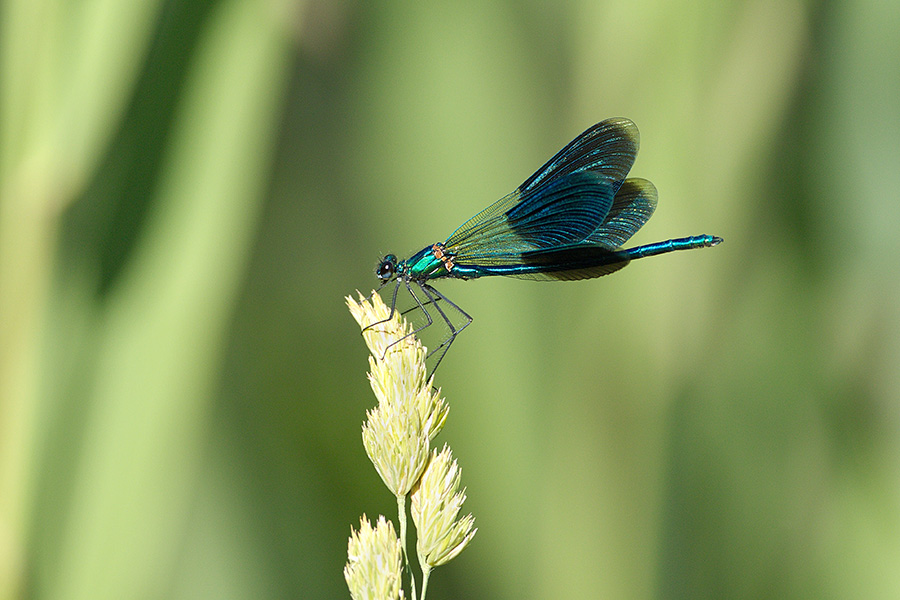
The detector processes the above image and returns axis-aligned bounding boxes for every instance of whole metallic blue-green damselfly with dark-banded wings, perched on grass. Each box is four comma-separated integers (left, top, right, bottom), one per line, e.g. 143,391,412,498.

370,118,722,372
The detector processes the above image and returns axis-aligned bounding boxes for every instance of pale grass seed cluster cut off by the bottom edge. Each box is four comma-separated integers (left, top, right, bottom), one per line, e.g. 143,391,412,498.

344,515,403,600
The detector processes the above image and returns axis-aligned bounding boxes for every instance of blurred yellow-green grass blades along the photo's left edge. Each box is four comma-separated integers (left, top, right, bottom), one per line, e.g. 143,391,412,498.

0,0,160,598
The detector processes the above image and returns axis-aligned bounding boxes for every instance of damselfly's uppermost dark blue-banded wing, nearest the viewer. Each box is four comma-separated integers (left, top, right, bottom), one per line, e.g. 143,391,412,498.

444,119,638,265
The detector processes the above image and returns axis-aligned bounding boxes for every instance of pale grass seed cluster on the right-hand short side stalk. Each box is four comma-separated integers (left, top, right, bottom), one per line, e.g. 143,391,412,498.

410,445,478,568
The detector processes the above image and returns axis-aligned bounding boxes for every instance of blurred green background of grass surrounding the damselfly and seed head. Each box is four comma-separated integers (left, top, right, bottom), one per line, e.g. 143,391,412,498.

0,0,900,599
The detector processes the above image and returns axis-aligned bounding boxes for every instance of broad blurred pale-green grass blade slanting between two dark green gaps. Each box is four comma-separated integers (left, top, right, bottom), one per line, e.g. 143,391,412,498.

48,0,289,599
